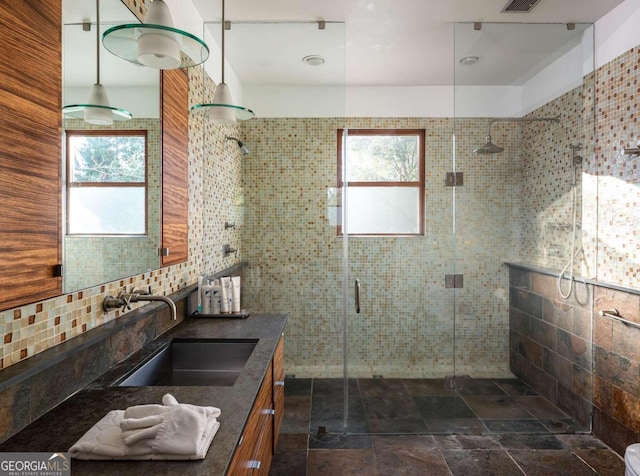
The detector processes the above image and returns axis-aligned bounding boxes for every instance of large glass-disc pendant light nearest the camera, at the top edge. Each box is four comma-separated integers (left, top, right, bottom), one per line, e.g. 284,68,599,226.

102,0,209,69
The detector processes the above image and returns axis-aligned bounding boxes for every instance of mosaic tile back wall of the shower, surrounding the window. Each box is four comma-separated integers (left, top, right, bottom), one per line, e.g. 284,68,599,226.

243,118,519,377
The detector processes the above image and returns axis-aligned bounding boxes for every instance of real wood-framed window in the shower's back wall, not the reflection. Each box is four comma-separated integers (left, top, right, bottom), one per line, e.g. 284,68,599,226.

338,129,424,236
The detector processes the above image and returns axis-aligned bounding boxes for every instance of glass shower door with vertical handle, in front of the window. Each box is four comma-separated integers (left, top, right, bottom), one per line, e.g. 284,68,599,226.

342,118,454,434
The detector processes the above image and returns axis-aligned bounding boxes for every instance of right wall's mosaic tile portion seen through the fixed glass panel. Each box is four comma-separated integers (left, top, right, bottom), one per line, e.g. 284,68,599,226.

521,79,595,277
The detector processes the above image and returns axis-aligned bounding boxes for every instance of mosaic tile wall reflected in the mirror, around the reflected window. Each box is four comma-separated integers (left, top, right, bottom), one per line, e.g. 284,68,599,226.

63,118,160,292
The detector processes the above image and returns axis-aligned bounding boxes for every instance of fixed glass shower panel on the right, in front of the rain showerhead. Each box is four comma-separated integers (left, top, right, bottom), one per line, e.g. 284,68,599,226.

454,23,593,430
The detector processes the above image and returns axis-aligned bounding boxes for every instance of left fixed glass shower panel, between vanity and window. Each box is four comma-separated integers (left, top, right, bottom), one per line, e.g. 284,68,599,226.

235,21,352,433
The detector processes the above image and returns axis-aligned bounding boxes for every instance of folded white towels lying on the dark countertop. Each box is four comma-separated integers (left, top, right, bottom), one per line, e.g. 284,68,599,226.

69,396,220,460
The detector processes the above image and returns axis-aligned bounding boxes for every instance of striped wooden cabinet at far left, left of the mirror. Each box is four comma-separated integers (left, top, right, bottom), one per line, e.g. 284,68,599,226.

0,0,62,310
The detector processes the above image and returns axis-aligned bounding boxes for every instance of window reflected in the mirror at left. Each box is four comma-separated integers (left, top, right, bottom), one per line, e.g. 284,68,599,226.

67,130,147,236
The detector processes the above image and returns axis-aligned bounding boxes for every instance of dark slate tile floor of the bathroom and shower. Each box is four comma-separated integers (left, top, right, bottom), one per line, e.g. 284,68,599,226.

270,378,624,476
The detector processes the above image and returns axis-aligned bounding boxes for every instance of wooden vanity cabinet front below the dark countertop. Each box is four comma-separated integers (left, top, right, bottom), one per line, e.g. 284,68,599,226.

227,337,284,476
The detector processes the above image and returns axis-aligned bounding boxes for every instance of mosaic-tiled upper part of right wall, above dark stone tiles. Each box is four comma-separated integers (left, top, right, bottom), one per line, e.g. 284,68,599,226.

522,48,640,290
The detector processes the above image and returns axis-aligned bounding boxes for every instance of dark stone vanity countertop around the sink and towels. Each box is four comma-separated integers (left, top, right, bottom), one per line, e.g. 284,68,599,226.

0,315,287,476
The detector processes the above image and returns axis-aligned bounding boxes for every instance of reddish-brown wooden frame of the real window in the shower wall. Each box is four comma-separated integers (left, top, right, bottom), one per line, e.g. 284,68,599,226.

336,128,426,238
